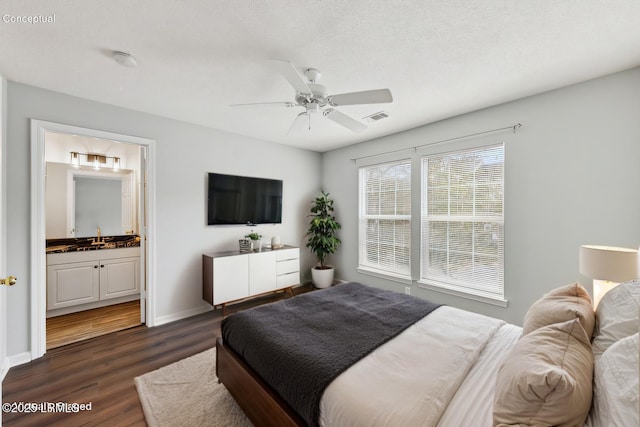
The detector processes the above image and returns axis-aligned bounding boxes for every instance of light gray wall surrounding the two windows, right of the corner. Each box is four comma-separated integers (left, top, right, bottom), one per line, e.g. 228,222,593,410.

322,68,640,324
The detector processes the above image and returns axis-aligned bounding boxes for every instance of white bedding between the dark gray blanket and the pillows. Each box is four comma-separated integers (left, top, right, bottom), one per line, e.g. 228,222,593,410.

320,306,520,427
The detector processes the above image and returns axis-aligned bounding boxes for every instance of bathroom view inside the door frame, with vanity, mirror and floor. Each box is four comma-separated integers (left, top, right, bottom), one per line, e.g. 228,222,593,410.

44,131,144,350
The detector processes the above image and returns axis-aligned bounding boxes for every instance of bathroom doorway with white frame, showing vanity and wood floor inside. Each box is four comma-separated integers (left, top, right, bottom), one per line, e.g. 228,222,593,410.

32,120,154,359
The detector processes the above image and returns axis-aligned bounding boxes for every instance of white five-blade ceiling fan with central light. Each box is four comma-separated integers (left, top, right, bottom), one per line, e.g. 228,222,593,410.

231,59,393,134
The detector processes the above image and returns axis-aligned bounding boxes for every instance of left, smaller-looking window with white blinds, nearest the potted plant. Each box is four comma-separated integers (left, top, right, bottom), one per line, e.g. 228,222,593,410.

359,159,411,279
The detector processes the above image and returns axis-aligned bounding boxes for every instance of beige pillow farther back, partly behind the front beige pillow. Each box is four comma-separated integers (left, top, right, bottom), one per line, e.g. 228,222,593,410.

522,283,595,337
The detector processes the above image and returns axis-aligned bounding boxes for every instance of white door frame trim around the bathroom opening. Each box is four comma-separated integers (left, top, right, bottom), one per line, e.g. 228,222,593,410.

30,119,156,360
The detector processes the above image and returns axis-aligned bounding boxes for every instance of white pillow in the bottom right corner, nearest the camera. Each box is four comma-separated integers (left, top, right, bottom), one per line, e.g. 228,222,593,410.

590,333,640,427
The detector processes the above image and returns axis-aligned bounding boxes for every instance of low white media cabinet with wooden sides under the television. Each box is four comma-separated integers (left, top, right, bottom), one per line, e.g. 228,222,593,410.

202,246,300,315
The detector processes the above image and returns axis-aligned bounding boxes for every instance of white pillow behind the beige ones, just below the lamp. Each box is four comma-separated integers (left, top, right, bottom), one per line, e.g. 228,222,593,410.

592,282,640,360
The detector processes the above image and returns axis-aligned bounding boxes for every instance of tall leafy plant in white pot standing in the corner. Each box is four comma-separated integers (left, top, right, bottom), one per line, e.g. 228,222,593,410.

307,191,340,288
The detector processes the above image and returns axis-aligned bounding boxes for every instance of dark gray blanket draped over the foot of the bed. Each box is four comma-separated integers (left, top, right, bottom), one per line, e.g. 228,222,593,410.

222,283,438,426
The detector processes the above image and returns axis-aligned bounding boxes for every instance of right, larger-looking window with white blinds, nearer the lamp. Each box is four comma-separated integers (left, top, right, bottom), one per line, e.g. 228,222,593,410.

420,144,504,300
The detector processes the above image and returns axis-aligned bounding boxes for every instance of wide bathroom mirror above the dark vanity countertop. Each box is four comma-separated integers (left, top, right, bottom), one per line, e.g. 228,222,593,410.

45,162,137,239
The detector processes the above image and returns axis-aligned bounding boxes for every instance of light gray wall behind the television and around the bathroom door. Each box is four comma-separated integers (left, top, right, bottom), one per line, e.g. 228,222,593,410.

6,82,321,355
